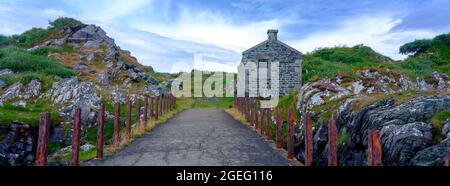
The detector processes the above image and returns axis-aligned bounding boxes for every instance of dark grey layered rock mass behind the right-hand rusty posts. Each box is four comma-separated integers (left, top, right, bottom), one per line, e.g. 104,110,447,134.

295,96,450,165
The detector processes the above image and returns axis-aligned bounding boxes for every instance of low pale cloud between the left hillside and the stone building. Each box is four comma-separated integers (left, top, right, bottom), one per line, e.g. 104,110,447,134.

102,25,241,72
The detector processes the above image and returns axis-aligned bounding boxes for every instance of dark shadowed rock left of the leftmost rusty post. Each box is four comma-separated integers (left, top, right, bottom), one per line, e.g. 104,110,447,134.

0,122,34,166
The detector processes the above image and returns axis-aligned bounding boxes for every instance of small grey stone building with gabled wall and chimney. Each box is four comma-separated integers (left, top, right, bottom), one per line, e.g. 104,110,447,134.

239,29,302,97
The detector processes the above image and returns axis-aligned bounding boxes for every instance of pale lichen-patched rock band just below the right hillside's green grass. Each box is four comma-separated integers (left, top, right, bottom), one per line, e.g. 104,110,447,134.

298,69,450,110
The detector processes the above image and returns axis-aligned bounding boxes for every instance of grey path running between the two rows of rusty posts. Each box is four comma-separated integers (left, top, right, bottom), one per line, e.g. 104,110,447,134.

95,109,291,166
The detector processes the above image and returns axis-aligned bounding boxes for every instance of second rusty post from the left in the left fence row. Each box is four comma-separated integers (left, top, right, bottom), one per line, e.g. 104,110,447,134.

69,108,81,166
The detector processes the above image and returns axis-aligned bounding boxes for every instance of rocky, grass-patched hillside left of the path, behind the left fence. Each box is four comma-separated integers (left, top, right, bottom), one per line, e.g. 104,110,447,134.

0,18,168,165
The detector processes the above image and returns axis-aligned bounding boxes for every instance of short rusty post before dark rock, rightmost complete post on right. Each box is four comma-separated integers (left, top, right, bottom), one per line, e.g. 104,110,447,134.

367,130,383,166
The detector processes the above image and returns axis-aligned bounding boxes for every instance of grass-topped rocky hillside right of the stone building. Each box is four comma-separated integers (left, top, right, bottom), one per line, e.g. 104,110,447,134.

290,34,450,165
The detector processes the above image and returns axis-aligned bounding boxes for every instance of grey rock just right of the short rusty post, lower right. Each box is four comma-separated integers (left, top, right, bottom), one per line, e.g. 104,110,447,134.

380,122,432,166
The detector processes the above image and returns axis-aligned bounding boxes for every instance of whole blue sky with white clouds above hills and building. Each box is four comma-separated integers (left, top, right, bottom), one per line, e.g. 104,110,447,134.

0,0,450,72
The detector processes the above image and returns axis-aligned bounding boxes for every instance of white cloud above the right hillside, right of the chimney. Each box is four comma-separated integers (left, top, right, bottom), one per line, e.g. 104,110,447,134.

287,15,438,59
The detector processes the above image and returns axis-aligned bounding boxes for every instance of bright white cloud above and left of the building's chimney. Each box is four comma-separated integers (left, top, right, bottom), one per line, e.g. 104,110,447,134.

130,7,289,53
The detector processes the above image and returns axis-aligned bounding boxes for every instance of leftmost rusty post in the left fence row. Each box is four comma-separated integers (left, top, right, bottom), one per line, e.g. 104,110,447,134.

36,112,50,166
